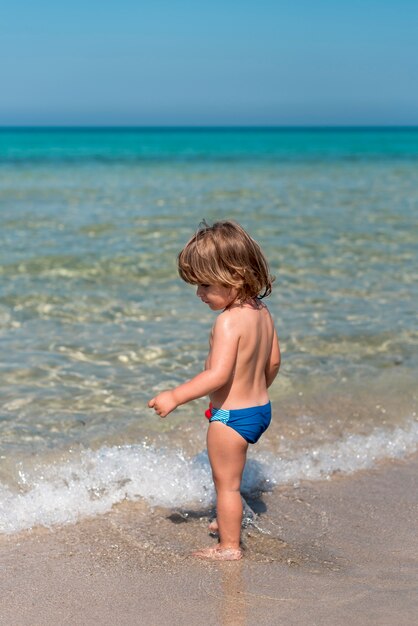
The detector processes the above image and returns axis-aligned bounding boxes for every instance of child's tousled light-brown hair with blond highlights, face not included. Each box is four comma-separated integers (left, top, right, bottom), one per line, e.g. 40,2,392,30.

178,221,274,302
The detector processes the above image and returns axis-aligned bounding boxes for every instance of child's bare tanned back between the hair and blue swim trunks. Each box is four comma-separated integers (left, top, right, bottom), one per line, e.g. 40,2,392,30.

206,300,280,410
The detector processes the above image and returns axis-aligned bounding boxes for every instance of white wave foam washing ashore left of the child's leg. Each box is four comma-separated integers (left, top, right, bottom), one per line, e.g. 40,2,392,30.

0,445,213,533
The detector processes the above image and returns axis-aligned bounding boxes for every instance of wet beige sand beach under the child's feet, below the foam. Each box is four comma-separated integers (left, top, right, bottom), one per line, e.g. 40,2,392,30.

0,456,418,626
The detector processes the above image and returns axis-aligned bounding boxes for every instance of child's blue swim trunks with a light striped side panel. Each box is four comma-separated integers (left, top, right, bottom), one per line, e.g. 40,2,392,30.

209,402,271,443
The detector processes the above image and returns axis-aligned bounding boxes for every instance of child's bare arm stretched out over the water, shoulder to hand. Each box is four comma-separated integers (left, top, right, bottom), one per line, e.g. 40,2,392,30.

148,314,239,417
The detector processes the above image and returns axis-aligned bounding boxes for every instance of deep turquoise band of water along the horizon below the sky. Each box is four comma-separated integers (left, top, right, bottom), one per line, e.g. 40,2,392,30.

0,128,418,163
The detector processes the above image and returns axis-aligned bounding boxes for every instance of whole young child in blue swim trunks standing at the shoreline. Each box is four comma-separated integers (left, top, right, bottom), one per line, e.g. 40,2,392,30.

148,221,280,561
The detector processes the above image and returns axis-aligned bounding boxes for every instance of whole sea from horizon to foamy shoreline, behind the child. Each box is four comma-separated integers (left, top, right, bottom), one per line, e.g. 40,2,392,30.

0,128,418,534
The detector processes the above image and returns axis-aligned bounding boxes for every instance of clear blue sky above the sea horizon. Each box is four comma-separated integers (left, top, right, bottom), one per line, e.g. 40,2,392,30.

0,0,418,126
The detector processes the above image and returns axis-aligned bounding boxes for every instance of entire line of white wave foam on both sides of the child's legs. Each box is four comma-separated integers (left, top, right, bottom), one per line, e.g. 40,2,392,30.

0,421,418,533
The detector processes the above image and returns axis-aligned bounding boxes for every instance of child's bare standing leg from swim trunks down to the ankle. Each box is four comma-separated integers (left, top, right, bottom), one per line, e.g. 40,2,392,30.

207,422,248,549
